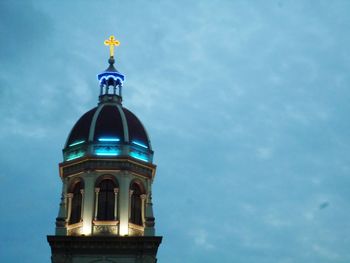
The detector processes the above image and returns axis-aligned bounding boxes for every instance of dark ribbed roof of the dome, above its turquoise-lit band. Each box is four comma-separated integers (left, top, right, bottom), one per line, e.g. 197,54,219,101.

65,103,151,150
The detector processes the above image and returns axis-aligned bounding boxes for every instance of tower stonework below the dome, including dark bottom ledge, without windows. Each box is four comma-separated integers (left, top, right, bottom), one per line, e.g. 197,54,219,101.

48,157,162,263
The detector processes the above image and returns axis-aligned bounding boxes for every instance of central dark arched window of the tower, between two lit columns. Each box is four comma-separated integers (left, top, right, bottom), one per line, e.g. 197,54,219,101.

97,179,116,220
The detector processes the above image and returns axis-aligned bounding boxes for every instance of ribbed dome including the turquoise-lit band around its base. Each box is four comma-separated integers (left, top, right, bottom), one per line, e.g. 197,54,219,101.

63,95,153,162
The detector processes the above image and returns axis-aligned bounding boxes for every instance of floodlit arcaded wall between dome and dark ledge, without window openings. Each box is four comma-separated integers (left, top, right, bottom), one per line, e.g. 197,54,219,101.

56,158,156,236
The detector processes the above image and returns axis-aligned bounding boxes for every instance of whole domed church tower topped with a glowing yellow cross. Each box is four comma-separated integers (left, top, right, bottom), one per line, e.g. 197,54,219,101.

47,36,162,263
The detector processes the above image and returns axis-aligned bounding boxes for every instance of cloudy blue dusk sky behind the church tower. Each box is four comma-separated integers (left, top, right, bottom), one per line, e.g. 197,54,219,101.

0,0,350,263
